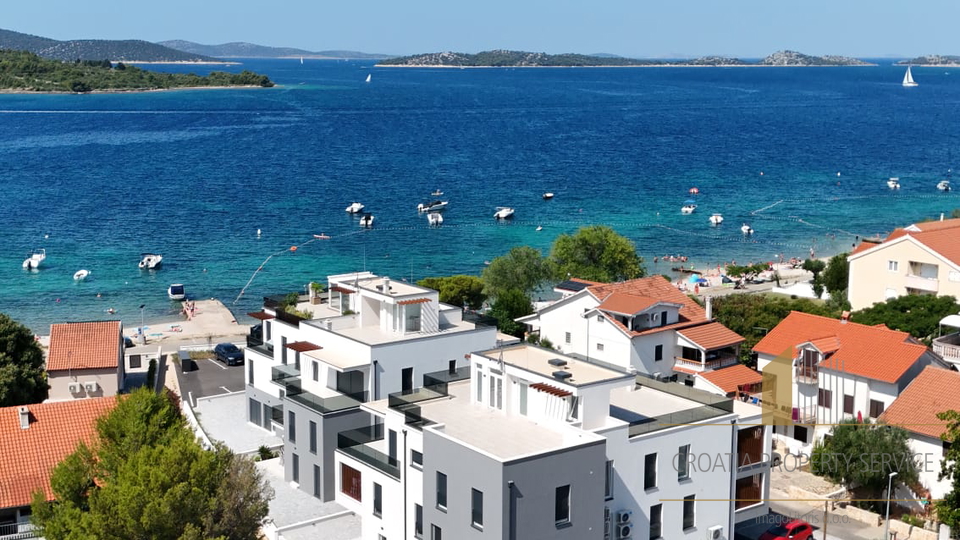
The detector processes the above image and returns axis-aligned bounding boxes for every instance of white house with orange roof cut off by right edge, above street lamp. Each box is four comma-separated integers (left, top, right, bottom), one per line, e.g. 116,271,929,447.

880,367,960,499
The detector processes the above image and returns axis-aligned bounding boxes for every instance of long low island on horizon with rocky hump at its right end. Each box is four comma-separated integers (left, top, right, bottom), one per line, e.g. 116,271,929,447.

377,50,875,67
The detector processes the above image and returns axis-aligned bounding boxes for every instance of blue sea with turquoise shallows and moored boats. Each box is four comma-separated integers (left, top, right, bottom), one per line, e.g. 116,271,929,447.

0,60,960,333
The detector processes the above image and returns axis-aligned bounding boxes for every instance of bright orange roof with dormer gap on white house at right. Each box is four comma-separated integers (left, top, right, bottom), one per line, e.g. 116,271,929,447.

753,311,927,383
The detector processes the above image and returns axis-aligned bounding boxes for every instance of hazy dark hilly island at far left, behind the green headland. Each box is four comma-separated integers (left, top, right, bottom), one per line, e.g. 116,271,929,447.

0,29,223,63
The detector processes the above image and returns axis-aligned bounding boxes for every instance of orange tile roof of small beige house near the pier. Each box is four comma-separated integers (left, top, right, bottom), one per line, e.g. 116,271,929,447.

47,321,122,371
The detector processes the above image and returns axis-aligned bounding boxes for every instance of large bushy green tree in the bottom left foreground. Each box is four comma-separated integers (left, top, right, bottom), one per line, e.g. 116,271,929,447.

33,389,273,540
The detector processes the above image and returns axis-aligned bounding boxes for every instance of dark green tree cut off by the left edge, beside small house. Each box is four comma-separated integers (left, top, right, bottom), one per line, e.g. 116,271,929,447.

0,313,48,407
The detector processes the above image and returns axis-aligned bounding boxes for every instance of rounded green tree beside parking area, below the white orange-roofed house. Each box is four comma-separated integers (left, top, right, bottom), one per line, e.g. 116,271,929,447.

811,419,919,506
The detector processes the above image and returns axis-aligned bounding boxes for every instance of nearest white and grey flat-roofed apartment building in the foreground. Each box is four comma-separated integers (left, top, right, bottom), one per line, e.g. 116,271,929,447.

336,344,770,540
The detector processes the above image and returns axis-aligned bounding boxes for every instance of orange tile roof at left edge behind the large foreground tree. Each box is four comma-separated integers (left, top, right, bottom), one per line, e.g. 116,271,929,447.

0,397,117,508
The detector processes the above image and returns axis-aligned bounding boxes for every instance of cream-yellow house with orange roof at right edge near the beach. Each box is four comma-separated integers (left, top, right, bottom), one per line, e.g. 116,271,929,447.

847,215,960,310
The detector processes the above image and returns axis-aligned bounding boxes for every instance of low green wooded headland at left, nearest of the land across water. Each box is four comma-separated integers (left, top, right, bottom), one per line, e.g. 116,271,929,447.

0,50,273,93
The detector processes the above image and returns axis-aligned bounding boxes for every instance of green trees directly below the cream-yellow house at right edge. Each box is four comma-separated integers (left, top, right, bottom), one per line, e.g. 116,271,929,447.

850,294,960,345
